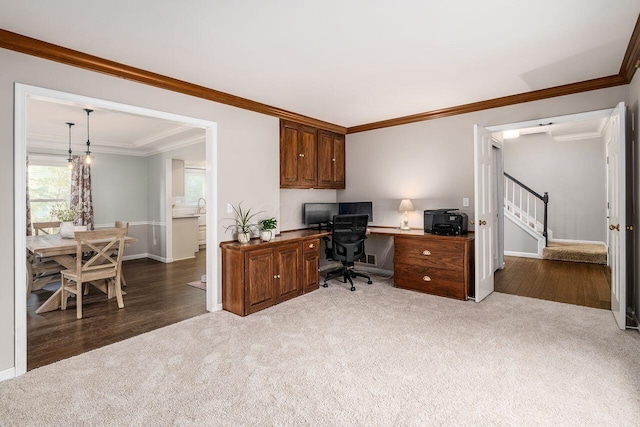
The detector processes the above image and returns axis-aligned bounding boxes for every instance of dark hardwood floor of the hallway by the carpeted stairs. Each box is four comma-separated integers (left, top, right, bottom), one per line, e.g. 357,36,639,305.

495,256,611,310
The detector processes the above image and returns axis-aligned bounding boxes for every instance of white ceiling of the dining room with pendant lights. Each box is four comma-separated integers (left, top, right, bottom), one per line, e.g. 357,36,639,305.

27,98,205,160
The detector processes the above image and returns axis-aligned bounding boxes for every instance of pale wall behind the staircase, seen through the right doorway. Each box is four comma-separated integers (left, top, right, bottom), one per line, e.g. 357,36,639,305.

503,133,607,242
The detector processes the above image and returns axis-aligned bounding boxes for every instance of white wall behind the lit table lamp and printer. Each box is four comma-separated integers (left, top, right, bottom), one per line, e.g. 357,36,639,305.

348,86,628,272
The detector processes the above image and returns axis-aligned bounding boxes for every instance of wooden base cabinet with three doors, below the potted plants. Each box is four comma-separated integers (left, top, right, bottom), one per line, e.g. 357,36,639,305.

221,234,320,316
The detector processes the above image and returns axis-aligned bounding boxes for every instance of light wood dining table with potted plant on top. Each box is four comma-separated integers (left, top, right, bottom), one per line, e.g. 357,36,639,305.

27,234,138,314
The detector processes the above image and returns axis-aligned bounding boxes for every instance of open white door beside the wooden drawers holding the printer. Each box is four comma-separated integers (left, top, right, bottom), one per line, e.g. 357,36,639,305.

473,125,496,302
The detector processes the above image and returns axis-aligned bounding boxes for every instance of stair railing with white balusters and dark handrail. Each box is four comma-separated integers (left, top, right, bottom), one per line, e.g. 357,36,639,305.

504,173,551,258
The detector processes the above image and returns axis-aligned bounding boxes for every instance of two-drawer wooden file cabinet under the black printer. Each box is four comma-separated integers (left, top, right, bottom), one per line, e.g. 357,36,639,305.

393,234,474,300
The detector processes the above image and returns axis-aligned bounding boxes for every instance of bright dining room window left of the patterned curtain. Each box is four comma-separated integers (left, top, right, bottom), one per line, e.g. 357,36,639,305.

29,156,71,222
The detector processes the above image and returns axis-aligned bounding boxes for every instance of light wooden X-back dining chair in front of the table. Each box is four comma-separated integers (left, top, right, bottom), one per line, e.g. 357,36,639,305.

60,228,127,319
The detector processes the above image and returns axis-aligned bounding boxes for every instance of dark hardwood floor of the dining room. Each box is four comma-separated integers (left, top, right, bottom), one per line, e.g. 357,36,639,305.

27,250,206,370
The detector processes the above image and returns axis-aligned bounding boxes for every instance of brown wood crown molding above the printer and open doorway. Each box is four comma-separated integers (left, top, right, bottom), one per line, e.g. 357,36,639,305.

347,75,627,134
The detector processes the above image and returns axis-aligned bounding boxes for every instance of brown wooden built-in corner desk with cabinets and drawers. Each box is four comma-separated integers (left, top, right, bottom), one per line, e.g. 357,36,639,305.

220,227,473,316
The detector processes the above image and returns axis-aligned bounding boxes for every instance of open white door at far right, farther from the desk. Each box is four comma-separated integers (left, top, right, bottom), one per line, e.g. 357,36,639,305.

607,102,627,329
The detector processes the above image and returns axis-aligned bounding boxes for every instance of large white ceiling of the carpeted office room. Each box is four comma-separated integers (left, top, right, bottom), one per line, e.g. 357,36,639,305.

0,0,640,127
